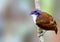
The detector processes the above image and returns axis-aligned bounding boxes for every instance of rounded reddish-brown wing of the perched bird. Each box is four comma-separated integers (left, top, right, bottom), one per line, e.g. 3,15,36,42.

36,12,56,29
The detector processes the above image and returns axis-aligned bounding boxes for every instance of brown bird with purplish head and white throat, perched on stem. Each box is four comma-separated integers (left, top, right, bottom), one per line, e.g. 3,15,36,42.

30,9,58,34
